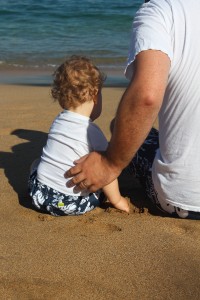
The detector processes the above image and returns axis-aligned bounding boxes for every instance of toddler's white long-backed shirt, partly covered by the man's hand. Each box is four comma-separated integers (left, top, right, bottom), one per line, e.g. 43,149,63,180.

37,110,108,196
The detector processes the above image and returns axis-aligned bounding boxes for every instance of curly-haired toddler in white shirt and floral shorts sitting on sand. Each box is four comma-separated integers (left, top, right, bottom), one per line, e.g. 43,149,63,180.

28,56,129,216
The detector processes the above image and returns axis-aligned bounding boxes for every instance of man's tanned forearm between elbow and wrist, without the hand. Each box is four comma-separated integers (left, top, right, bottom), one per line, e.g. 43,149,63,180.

106,84,159,170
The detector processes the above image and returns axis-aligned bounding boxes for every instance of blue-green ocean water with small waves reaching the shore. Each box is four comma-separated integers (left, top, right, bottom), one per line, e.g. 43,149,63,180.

0,0,144,84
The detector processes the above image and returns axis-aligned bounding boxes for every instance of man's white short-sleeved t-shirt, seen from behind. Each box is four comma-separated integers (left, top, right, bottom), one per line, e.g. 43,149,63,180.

125,0,200,211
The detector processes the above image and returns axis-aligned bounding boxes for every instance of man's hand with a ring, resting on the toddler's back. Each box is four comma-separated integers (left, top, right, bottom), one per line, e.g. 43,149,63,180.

65,152,121,192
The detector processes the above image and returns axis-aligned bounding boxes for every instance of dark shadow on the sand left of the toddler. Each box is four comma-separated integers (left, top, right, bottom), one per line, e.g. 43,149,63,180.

0,129,47,209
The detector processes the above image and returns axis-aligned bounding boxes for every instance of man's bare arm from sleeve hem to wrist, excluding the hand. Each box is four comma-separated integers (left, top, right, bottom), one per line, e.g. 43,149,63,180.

107,50,170,170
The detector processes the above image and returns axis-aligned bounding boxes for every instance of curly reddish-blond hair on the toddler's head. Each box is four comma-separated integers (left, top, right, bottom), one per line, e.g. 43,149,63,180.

51,55,106,109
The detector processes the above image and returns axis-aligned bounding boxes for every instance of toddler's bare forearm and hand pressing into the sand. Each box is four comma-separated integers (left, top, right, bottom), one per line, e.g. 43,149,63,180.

103,179,130,213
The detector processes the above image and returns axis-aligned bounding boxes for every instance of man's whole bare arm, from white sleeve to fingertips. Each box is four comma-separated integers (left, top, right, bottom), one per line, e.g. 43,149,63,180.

66,50,170,191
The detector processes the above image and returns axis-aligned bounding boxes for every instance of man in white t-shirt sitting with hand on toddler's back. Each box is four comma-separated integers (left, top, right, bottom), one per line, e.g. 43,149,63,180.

66,0,200,219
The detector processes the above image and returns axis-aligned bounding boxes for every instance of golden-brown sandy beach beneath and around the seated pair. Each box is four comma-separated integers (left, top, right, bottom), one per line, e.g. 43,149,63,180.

0,85,200,300
